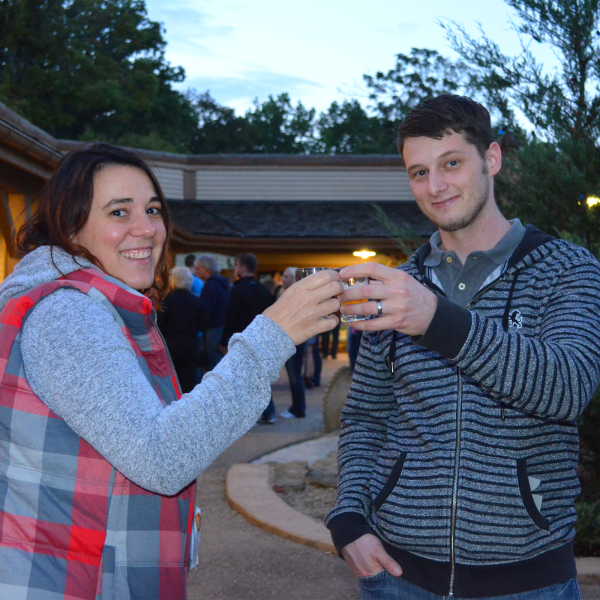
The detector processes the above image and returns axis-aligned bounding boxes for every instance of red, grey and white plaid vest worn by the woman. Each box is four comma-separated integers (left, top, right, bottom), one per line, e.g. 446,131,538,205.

0,268,195,600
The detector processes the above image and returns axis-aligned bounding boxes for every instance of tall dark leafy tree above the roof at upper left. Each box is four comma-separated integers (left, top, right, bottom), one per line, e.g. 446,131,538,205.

0,0,196,152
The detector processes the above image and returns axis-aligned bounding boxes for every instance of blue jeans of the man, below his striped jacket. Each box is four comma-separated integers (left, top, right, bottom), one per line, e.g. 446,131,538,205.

358,571,581,600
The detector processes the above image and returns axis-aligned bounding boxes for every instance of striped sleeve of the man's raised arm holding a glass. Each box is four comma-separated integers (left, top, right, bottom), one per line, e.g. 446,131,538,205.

416,258,600,421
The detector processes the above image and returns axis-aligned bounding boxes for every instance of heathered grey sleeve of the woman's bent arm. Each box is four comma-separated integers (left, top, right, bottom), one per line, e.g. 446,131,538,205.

21,290,294,495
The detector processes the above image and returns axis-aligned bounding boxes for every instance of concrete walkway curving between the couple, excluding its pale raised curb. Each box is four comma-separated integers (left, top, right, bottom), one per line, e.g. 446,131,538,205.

189,355,358,600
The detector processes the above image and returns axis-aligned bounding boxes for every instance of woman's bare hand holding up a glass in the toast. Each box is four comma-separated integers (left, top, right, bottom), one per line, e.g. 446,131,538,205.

263,270,344,346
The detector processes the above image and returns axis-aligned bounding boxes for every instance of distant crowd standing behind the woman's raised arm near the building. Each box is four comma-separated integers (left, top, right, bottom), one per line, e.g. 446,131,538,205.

158,253,362,425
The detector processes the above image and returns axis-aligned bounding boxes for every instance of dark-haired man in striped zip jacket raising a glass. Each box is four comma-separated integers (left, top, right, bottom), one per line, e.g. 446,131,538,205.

327,95,600,600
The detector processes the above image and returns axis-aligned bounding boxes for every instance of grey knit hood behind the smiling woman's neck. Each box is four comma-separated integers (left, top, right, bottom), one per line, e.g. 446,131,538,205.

0,246,95,310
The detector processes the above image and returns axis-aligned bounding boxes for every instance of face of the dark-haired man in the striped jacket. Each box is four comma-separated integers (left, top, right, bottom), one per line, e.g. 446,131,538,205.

403,132,501,231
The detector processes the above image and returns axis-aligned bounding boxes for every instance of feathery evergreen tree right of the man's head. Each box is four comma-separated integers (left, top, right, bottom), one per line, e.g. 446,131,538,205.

443,0,600,255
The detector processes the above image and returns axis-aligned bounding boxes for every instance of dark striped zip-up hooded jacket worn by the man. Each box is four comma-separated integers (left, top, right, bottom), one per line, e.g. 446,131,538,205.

326,226,600,598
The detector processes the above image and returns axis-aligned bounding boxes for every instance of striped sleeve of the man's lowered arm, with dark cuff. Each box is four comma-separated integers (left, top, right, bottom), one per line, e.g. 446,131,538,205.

325,331,397,553
